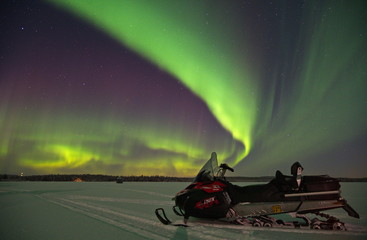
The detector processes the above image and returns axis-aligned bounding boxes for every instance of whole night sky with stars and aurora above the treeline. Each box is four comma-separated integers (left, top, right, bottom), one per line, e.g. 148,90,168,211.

0,0,367,177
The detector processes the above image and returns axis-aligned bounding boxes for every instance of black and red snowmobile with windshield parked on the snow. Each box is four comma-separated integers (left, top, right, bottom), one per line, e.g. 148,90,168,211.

155,152,359,230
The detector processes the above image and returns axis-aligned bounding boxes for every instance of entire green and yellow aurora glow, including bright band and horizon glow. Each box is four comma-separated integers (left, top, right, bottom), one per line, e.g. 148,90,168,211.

0,0,367,176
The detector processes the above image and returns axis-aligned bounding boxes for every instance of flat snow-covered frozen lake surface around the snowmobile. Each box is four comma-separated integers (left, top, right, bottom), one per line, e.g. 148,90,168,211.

0,182,367,240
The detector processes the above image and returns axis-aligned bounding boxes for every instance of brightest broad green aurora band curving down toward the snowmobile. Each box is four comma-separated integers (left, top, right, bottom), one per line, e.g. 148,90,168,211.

47,0,259,163
